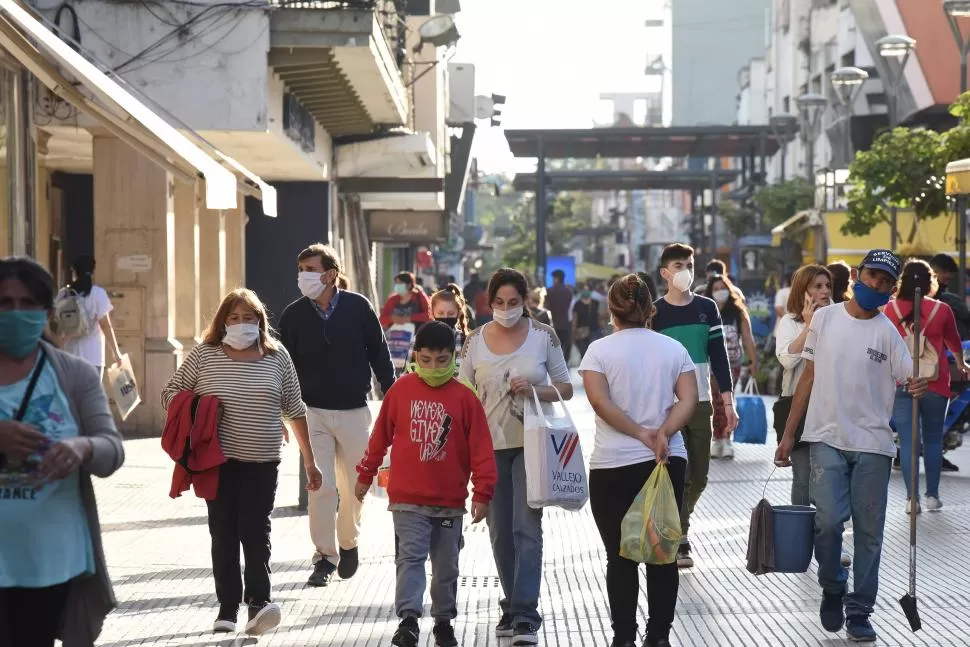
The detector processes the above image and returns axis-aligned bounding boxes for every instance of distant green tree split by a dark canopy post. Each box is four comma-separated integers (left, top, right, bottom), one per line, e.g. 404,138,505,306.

502,193,591,277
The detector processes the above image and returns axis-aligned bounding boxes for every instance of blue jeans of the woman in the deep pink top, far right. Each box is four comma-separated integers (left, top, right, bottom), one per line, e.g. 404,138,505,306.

893,389,950,497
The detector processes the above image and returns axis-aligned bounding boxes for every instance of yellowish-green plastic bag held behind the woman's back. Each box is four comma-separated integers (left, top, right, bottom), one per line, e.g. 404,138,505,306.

620,463,681,565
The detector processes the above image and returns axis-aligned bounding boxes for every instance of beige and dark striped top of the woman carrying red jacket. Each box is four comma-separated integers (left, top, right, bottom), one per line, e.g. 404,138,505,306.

162,344,306,463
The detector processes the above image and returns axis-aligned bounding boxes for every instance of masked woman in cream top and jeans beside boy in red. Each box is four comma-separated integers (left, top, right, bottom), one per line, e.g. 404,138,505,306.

459,268,573,645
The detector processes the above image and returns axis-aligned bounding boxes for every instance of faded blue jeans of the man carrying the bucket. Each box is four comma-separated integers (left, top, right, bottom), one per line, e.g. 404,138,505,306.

810,443,893,616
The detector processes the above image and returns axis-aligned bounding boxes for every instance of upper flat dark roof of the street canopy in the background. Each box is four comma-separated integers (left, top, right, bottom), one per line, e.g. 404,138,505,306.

505,125,792,159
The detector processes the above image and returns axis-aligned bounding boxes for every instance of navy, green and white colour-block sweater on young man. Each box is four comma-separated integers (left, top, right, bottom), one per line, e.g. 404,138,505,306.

652,295,733,402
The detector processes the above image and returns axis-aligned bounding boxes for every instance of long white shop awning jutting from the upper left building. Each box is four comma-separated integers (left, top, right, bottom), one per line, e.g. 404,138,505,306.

0,0,276,217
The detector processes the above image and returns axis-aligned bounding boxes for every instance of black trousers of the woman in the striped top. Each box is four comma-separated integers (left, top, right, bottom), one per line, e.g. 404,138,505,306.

206,460,279,609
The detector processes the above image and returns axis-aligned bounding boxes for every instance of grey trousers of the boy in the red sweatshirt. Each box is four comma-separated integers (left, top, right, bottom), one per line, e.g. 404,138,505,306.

393,511,462,621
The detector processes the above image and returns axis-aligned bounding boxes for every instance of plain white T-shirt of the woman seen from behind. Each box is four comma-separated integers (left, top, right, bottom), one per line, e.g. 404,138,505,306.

579,328,694,469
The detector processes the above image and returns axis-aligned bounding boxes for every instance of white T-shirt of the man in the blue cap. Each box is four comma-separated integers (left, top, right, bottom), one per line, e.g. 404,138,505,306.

802,303,913,457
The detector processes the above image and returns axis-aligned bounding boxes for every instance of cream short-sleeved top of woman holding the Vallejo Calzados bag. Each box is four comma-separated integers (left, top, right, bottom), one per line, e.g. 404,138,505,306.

458,319,569,450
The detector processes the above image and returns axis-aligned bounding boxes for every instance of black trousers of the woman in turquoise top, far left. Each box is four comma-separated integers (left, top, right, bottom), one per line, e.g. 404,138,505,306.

0,582,71,647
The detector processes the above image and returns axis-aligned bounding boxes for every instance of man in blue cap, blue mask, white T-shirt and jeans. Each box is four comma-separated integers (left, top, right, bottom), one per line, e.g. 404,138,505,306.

775,249,927,642
